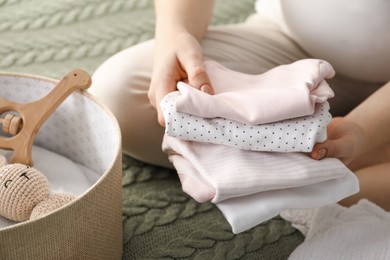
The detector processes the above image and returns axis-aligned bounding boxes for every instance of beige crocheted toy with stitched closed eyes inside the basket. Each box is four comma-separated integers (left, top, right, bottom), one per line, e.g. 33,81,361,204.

0,155,76,221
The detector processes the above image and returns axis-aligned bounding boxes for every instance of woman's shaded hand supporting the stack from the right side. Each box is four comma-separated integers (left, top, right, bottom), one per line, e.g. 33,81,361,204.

310,117,365,165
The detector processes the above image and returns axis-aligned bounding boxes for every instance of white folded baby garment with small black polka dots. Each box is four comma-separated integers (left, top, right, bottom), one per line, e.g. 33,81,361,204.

160,91,332,152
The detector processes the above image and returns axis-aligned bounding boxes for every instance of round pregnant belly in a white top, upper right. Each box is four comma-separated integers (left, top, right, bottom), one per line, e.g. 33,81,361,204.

281,0,390,82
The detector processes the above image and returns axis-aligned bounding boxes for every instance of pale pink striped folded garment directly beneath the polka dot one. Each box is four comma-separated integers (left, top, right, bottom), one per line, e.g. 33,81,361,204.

163,135,350,203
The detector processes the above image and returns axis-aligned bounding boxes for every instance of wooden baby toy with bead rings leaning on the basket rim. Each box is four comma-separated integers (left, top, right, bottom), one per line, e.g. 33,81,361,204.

0,69,91,165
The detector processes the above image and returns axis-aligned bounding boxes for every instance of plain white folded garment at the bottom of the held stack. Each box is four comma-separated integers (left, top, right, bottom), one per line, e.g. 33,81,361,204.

216,172,359,234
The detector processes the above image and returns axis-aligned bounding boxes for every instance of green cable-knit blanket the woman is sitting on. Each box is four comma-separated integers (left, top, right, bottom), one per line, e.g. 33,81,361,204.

0,0,303,260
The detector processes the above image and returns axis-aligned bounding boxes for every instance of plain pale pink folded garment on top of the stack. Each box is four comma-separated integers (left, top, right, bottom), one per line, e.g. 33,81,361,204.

176,59,335,124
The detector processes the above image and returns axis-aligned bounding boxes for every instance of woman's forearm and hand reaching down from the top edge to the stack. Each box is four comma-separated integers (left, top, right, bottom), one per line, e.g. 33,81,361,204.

148,0,214,126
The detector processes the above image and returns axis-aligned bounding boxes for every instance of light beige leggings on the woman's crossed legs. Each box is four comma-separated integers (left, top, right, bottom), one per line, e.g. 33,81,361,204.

90,14,380,168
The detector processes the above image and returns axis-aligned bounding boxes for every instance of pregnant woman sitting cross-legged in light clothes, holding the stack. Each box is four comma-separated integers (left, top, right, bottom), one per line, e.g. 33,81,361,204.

91,0,390,210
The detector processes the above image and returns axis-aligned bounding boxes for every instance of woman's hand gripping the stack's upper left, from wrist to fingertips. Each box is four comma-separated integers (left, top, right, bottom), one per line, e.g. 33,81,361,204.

148,32,213,126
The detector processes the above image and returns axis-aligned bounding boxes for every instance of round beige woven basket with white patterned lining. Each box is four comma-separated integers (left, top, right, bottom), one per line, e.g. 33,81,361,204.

0,73,122,260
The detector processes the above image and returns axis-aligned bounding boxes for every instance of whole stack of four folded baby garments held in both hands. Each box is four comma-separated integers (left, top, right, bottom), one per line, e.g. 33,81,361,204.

160,59,358,233
